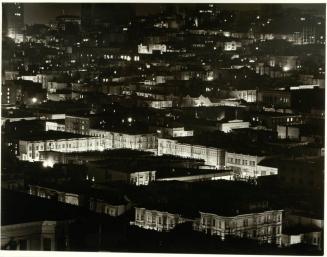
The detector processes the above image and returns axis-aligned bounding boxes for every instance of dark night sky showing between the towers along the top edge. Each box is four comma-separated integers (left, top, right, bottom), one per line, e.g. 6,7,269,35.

24,3,325,24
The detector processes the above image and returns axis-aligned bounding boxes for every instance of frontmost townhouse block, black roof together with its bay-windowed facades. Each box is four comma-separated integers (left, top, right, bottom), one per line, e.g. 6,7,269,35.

132,180,283,245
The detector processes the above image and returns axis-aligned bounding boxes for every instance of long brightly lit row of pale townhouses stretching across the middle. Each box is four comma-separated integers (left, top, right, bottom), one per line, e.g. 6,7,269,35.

19,129,278,177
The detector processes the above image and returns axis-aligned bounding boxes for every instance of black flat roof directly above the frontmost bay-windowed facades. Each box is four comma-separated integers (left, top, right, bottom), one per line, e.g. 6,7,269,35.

137,180,278,217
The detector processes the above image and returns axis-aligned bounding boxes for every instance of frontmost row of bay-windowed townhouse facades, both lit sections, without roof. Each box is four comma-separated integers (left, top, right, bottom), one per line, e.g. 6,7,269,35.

131,207,283,245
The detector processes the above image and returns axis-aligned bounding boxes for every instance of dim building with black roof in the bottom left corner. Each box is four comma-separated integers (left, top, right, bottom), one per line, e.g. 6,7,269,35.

1,189,81,251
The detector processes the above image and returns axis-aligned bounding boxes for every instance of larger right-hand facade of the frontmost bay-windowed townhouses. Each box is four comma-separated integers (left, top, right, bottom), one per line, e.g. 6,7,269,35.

198,210,282,245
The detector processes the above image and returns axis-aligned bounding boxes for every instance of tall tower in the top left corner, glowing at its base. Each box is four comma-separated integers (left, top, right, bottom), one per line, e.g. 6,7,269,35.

2,3,24,43
